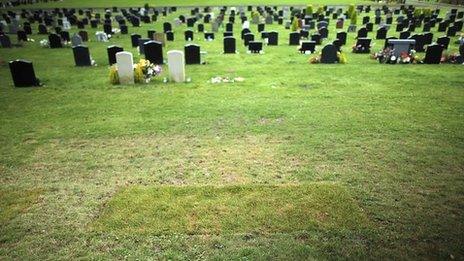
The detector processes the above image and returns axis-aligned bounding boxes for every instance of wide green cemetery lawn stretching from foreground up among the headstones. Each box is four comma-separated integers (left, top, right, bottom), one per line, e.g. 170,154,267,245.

0,4,464,260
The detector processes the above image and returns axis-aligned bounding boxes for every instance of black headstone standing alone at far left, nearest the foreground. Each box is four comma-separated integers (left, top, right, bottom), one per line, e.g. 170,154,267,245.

9,60,40,87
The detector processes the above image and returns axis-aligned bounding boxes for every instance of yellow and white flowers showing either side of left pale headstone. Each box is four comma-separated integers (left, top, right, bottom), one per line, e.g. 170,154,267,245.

109,59,163,84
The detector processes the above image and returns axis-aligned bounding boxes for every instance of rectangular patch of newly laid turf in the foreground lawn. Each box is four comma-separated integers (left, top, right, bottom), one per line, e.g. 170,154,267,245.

94,183,366,235
